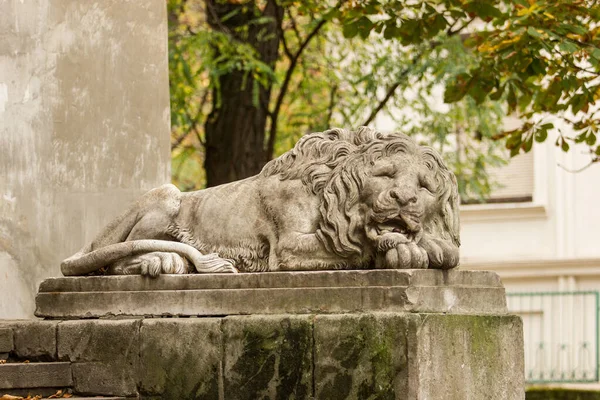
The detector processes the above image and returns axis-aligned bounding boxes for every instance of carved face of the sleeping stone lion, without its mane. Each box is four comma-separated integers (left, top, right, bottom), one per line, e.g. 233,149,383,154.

360,154,438,251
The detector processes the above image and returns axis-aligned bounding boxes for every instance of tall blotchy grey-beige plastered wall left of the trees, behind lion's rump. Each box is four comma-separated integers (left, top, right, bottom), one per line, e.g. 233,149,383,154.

0,0,170,318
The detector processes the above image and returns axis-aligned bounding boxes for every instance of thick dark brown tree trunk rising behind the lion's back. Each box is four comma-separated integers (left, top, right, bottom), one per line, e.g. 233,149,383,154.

204,0,283,186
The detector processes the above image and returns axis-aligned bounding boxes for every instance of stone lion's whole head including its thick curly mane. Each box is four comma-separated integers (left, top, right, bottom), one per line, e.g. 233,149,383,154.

262,127,460,268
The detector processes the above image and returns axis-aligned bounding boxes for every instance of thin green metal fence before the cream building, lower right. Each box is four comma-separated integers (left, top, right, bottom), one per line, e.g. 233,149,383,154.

506,291,600,383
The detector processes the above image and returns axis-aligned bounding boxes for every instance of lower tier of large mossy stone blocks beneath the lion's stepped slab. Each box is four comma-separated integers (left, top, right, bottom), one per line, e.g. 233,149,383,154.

2,312,524,400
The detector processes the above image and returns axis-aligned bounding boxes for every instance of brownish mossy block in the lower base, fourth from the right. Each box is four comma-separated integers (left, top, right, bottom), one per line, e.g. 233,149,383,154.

139,318,223,400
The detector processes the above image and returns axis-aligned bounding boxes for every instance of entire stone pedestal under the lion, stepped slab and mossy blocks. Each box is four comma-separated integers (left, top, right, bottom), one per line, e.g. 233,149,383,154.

27,270,524,400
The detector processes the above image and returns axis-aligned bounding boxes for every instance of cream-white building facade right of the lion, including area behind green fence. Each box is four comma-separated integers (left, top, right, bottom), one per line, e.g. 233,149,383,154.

461,130,600,384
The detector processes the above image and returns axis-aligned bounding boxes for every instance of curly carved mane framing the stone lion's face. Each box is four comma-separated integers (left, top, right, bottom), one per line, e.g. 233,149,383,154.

261,127,460,257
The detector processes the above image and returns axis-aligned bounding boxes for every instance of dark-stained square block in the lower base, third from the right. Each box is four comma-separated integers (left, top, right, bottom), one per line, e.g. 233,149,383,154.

223,316,313,400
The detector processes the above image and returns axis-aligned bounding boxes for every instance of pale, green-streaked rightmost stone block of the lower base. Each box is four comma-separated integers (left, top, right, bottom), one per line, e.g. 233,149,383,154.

407,314,525,400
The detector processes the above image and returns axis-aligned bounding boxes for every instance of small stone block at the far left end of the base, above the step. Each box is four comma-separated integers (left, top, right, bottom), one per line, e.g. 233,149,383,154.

2,320,58,361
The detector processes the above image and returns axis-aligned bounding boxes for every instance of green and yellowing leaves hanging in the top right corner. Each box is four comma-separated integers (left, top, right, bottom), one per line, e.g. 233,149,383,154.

339,0,600,162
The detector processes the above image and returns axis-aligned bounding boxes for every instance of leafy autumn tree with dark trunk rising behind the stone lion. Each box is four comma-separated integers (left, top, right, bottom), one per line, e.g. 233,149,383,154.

168,0,600,197
